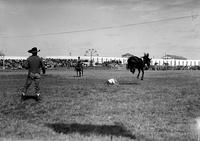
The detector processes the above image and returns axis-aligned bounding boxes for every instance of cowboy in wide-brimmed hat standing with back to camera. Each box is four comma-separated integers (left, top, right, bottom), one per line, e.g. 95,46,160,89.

22,47,46,101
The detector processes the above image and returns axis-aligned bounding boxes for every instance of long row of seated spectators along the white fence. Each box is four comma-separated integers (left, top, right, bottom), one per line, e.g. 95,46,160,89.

0,58,200,70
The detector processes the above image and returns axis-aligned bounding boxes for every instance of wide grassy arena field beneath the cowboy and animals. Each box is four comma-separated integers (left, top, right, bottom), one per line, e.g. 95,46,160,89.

0,70,200,141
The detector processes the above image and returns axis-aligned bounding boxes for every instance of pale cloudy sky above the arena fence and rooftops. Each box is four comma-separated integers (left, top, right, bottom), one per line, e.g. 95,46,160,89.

0,0,200,59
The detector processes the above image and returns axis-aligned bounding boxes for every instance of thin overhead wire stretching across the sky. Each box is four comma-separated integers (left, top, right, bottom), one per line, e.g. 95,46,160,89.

0,15,199,38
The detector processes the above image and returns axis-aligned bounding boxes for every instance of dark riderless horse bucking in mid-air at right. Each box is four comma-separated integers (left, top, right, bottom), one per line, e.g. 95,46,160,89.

127,53,151,80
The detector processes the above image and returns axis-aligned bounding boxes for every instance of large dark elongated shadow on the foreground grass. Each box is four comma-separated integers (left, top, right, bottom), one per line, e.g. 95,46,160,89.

46,123,136,139
